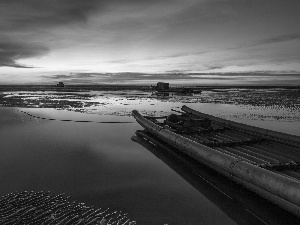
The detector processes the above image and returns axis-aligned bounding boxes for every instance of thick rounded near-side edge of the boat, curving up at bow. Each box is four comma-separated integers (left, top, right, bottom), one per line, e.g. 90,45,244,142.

132,110,300,217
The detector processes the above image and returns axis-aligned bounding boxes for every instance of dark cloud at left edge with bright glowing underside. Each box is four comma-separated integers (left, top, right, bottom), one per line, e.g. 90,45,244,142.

0,41,48,68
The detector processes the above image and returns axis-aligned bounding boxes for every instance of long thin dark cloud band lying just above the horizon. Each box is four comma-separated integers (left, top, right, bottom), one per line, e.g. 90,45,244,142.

43,71,300,85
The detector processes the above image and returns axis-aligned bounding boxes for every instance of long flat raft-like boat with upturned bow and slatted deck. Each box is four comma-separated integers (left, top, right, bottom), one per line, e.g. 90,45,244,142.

132,106,300,217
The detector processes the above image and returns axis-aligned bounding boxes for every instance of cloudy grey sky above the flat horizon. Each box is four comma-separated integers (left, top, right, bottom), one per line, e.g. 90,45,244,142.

0,0,300,85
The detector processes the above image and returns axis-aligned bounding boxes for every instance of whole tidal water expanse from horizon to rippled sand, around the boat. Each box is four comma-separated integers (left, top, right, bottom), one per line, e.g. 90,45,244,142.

0,85,300,225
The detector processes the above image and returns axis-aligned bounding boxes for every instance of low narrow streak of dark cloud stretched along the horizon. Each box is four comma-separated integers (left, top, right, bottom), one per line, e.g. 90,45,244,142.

40,71,300,85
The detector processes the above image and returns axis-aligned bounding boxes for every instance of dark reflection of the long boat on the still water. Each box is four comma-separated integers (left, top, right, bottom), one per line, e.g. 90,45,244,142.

132,131,299,225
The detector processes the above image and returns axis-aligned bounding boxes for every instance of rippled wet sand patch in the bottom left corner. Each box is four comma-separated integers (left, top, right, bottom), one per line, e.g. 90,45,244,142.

0,191,136,225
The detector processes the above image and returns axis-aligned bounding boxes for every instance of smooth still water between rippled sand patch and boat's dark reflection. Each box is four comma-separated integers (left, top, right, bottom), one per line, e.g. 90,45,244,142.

0,108,235,225
